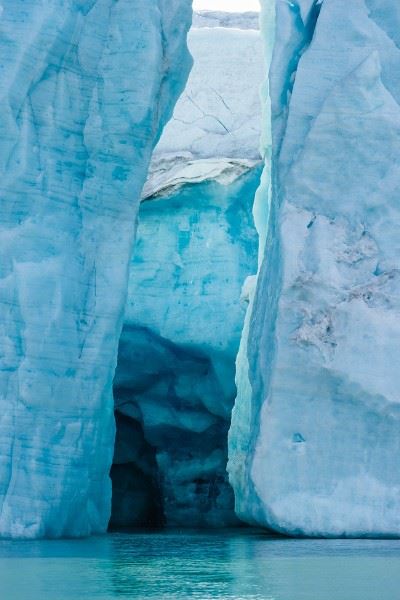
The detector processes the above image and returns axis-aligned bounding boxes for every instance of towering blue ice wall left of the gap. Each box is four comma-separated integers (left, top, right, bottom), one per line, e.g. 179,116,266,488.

0,0,191,538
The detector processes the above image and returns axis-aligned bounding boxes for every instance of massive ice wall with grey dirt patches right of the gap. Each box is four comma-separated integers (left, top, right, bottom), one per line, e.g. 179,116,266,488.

230,0,400,536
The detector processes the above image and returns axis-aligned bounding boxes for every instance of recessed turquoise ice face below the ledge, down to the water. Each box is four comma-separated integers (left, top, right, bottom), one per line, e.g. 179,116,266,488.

112,167,261,527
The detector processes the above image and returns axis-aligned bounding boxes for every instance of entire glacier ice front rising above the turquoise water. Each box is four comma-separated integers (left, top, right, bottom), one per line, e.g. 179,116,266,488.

0,0,400,543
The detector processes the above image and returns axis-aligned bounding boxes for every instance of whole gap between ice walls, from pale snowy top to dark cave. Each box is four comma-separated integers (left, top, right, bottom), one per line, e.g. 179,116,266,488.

110,4,265,529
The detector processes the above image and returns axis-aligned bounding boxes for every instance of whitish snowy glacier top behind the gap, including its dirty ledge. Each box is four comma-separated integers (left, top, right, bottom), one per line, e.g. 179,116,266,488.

143,12,265,198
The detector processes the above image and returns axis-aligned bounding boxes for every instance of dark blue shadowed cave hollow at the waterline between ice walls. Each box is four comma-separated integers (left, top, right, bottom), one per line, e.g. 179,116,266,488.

110,327,238,530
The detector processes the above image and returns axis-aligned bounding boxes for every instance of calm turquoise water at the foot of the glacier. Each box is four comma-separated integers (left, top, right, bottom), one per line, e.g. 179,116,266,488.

0,530,400,600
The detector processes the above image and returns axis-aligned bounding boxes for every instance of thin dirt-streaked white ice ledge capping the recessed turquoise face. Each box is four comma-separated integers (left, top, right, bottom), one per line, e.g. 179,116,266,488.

142,153,261,201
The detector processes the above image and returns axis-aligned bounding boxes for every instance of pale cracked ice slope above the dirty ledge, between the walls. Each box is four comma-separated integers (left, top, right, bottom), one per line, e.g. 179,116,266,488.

154,27,263,160
